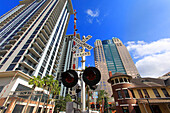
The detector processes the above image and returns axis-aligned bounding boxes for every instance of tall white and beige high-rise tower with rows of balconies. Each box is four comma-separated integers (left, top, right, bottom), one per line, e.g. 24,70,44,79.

0,0,73,112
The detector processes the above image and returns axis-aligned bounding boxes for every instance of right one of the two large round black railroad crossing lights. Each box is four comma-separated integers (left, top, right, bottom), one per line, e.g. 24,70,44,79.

83,67,101,87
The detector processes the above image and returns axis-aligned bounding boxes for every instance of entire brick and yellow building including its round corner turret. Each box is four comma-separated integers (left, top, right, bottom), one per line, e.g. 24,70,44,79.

108,73,170,113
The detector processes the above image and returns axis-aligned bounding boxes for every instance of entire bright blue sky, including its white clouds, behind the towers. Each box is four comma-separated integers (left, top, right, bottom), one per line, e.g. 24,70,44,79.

0,0,170,77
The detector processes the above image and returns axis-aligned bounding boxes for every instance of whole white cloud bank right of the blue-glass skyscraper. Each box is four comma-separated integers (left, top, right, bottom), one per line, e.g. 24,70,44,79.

127,38,170,77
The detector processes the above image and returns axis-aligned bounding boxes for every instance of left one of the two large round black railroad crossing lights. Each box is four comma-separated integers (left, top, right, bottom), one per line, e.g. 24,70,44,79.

61,70,78,88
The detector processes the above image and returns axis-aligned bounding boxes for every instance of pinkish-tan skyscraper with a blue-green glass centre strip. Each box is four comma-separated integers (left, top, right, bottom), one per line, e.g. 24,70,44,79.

94,37,140,90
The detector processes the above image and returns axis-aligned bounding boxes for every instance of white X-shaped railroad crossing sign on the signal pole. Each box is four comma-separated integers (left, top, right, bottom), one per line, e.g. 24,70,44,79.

72,35,93,51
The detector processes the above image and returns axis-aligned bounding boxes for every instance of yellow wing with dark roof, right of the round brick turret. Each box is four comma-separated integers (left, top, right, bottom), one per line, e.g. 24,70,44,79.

129,78,170,113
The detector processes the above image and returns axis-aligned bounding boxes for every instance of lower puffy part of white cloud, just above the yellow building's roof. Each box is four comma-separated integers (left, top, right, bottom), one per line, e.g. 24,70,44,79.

136,52,170,77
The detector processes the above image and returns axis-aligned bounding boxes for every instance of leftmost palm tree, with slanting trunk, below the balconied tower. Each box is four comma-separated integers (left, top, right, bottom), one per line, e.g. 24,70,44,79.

24,76,42,113
